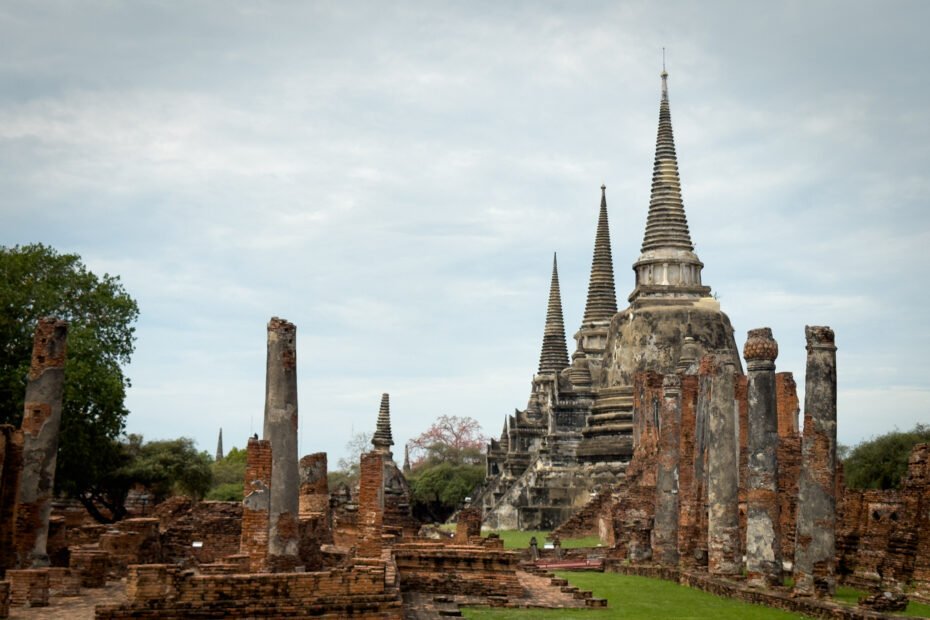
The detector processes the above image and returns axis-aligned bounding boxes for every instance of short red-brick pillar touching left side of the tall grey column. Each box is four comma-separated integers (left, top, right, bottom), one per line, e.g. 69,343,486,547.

239,437,271,573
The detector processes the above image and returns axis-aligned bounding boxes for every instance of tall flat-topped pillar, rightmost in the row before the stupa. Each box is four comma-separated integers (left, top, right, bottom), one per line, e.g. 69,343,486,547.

794,326,836,596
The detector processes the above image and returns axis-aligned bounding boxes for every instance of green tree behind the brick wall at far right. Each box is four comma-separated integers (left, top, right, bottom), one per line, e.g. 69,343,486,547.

843,424,930,489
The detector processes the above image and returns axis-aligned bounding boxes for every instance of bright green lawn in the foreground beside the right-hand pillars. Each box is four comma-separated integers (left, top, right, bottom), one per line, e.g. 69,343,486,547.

463,572,804,620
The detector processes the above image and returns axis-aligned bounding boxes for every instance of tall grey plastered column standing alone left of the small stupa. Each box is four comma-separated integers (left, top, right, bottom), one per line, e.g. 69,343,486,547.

264,317,300,572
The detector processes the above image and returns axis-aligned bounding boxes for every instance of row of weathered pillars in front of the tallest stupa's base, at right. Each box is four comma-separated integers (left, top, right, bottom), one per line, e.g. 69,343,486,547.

644,327,836,595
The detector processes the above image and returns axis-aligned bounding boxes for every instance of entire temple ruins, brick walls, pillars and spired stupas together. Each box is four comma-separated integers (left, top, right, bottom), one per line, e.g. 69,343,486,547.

0,72,930,620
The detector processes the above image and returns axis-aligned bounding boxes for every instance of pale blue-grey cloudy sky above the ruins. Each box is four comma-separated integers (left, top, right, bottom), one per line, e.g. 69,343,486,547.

0,0,930,463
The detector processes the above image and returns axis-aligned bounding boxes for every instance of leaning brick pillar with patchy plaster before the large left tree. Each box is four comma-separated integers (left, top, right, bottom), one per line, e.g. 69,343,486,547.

15,318,68,568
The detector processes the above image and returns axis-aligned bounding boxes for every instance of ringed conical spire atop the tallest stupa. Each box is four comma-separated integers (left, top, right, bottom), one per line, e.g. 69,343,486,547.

642,68,694,252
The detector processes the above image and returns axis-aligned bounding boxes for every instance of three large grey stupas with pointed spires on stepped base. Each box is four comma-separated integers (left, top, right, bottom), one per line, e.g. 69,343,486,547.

480,70,741,529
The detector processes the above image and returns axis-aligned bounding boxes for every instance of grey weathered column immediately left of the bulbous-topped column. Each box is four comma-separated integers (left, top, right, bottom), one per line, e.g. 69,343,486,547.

700,355,740,575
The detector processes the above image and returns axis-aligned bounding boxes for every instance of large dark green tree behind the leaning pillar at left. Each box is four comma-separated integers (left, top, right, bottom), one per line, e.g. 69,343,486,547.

0,244,139,516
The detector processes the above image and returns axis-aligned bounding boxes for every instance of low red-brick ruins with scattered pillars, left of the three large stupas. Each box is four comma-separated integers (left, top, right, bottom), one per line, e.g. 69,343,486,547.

0,318,606,620
